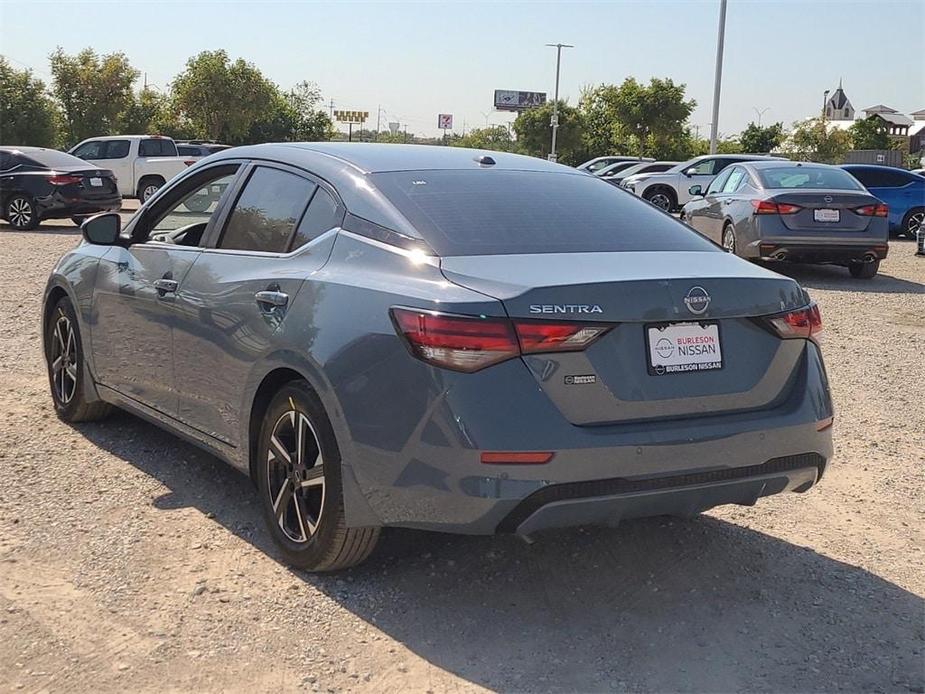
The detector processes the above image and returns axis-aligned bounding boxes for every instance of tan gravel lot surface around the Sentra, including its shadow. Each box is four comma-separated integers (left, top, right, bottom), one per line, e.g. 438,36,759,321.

0,213,925,692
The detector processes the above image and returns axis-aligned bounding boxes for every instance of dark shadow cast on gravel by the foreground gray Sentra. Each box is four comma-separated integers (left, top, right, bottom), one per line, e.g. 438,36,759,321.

79,413,925,692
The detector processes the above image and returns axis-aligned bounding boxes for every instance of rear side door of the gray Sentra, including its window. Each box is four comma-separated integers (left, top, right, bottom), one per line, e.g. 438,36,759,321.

174,163,344,445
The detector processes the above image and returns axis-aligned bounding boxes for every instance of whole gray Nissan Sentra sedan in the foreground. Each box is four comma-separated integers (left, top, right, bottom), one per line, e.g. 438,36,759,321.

43,143,833,570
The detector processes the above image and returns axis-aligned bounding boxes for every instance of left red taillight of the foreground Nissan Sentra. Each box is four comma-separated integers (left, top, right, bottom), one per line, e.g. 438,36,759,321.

391,308,610,373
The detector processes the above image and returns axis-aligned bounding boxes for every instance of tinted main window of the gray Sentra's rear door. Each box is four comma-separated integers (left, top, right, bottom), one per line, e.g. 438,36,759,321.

218,167,315,253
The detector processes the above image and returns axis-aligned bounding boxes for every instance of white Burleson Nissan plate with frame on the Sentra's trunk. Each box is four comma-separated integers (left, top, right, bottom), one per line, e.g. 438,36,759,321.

643,321,726,376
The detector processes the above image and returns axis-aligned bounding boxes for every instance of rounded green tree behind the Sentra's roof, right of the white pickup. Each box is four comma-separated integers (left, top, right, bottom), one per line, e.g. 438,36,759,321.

172,50,281,144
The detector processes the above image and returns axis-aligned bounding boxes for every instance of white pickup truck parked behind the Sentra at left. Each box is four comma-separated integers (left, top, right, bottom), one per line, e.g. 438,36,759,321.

68,135,195,202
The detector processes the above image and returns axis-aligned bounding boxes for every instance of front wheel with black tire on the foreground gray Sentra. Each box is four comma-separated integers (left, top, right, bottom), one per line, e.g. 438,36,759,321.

44,296,112,422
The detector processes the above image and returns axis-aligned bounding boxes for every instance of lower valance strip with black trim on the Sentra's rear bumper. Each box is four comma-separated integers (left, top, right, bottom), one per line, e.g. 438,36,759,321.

498,453,826,535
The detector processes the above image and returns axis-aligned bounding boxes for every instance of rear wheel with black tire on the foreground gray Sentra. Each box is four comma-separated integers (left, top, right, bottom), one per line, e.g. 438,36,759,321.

255,381,379,571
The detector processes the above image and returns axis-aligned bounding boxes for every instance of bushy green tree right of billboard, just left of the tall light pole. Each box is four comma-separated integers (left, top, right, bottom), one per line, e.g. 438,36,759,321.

607,77,697,157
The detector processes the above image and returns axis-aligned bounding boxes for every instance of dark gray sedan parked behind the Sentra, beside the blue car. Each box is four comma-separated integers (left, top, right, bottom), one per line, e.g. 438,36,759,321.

681,161,889,279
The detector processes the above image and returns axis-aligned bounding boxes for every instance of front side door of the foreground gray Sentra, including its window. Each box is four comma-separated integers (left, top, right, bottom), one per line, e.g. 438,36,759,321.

91,163,241,416
